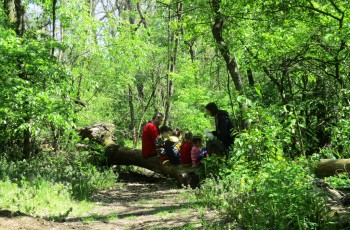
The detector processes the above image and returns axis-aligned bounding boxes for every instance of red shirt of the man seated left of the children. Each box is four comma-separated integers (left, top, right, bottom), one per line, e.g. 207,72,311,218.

142,122,160,157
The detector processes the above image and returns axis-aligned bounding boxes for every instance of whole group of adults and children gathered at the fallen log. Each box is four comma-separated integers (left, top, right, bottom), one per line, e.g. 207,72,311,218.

142,103,234,167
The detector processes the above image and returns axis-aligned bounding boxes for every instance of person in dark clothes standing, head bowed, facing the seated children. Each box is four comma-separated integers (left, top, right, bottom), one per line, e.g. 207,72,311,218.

205,102,234,149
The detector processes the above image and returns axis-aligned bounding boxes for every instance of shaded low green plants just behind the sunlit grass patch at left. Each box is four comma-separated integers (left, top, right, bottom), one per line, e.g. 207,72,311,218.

0,153,116,200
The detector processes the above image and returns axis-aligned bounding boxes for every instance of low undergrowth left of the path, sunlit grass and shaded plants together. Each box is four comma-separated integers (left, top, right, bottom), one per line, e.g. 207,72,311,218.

0,153,117,221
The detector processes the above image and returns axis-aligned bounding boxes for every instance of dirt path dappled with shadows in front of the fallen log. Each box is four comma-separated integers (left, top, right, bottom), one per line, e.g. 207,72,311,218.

0,170,223,230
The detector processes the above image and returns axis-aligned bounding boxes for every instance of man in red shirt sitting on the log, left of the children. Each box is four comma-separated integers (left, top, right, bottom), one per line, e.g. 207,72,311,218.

142,113,163,158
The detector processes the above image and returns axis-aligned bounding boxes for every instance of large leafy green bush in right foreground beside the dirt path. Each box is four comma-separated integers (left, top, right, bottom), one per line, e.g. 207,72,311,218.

197,107,332,229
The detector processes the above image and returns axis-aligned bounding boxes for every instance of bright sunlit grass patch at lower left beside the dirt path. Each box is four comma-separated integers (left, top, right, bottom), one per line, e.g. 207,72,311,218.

0,180,94,221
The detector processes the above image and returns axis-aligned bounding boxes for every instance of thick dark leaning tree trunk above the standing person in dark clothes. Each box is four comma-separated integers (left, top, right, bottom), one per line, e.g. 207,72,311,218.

211,0,243,91
